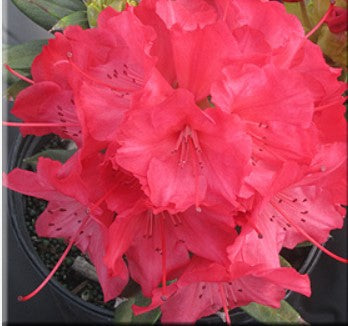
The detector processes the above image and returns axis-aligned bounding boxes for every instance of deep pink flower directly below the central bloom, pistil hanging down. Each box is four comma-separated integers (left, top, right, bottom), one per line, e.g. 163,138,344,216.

105,203,235,296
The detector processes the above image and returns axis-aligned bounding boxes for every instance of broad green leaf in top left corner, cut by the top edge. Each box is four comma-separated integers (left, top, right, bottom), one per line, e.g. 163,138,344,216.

12,0,85,30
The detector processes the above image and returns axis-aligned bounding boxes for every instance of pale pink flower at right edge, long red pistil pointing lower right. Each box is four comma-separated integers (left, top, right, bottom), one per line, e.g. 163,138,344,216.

248,144,347,253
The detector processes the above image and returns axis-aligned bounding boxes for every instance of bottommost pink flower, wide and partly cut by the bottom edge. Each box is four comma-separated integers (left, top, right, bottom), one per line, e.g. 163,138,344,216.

133,257,311,323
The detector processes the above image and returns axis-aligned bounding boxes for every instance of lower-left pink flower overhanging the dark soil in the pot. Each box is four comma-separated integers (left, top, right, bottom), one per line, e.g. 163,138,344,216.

4,154,128,301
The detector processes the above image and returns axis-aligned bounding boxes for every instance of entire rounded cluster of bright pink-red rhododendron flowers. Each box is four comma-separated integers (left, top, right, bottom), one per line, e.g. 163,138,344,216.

4,0,347,323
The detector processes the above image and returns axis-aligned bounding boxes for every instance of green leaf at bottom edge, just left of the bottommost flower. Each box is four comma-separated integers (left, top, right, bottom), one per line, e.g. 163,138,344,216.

114,293,161,325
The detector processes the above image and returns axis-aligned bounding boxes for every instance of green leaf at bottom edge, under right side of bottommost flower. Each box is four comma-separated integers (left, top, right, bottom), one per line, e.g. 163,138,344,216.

241,300,308,324
